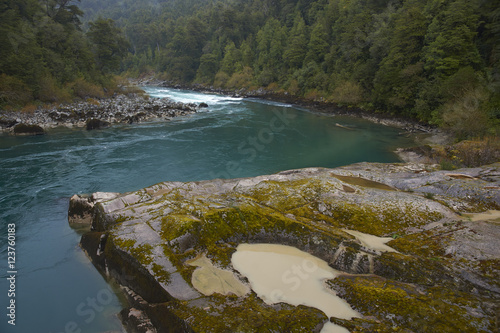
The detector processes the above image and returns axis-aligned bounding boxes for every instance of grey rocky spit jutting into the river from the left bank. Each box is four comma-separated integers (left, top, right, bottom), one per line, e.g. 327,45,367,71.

0,94,201,134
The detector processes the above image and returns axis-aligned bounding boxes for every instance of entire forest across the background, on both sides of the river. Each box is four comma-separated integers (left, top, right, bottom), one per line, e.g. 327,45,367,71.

0,0,500,138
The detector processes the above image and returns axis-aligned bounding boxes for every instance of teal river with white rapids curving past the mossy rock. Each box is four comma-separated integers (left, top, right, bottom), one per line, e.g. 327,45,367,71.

0,87,411,333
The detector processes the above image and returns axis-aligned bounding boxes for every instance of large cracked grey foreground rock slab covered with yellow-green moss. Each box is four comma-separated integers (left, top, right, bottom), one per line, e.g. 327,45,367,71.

69,163,500,332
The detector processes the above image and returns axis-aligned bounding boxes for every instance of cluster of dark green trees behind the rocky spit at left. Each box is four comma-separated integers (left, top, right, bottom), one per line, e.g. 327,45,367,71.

0,0,130,108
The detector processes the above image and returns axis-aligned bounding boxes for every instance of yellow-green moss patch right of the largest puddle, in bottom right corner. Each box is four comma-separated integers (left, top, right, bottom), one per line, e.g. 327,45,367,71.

330,276,494,333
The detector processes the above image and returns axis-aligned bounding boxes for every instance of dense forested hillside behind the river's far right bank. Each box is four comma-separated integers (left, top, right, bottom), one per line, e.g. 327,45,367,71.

78,0,500,139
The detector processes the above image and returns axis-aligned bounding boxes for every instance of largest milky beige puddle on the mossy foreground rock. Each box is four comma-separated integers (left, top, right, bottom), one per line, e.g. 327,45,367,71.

231,244,360,333
